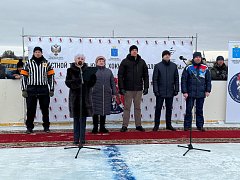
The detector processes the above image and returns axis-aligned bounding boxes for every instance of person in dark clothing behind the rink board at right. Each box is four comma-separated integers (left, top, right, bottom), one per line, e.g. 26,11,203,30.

211,56,228,81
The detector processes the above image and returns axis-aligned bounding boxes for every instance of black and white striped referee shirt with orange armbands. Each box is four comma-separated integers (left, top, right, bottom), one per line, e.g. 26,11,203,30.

21,59,54,91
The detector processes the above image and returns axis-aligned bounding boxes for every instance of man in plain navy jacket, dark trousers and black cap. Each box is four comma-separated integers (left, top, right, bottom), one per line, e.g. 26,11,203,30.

152,50,179,131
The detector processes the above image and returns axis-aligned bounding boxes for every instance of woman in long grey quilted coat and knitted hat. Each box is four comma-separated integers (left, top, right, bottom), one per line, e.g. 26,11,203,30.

91,56,116,134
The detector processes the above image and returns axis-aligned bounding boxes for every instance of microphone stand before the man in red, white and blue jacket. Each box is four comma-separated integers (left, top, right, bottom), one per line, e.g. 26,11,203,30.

178,56,211,156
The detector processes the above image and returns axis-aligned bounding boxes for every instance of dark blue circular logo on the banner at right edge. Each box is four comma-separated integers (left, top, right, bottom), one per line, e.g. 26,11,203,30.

228,73,240,103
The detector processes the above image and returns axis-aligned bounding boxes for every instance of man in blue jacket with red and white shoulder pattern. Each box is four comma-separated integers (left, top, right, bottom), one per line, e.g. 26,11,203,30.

181,52,212,131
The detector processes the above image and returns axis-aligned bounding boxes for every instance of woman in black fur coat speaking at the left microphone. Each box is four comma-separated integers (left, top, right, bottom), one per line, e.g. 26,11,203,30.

65,54,97,144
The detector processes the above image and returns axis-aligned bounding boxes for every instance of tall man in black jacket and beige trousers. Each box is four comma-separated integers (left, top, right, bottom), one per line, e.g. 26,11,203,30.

118,45,149,132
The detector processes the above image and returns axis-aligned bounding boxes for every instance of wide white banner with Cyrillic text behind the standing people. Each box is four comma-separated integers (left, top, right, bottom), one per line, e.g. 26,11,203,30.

25,37,193,122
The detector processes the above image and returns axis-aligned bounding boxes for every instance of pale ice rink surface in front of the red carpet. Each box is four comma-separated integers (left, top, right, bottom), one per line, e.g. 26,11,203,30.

0,143,240,180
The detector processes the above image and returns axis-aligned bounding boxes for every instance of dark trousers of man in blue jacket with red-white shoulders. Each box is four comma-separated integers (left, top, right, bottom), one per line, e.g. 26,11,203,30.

184,97,205,128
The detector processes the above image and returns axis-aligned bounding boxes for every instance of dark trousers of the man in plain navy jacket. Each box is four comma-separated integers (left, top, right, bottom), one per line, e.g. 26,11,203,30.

154,96,173,126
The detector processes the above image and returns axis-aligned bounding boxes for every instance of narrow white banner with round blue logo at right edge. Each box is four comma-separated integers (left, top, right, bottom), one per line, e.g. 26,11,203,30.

226,41,240,123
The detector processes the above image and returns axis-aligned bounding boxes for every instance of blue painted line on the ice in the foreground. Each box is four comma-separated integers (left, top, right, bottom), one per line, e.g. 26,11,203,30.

104,145,136,180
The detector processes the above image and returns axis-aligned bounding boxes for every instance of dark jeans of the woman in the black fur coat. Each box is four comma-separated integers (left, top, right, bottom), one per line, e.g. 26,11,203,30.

73,117,87,142
